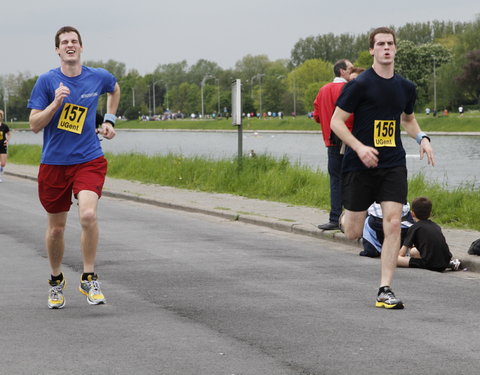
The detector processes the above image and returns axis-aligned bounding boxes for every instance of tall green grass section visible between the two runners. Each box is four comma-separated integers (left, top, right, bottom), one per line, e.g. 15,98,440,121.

107,154,329,207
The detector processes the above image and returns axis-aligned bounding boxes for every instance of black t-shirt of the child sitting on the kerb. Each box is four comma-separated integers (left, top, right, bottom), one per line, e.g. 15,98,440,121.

403,220,452,268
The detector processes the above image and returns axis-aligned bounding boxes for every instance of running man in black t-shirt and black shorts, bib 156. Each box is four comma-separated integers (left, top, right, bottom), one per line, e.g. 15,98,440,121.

331,27,435,309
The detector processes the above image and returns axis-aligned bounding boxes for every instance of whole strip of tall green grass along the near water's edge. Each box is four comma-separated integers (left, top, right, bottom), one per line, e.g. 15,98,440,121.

9,145,480,230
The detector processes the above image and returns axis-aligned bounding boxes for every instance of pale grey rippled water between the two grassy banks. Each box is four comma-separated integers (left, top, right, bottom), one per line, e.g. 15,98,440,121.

11,130,480,187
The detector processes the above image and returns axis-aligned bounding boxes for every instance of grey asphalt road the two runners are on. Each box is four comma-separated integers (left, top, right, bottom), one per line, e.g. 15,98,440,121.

0,177,480,375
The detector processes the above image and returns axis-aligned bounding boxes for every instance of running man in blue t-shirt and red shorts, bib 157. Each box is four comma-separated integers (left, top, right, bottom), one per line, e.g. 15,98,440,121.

28,26,120,309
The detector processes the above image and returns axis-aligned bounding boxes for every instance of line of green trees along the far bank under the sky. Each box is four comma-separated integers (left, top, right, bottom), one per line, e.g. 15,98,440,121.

0,16,480,121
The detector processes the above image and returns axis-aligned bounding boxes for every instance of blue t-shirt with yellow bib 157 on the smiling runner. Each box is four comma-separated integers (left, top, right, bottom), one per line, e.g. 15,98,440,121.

28,66,117,165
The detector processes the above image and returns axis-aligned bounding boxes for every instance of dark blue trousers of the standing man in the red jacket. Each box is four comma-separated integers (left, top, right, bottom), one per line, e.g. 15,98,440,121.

327,146,343,223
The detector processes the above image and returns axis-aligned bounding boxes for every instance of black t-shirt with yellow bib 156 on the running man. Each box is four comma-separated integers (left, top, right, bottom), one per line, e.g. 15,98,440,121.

337,68,416,172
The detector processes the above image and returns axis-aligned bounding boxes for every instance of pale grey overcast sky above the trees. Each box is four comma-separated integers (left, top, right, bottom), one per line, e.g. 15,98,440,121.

0,0,480,75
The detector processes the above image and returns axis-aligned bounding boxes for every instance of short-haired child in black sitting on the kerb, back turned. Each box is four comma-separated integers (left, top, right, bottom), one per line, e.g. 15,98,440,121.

397,197,461,272
